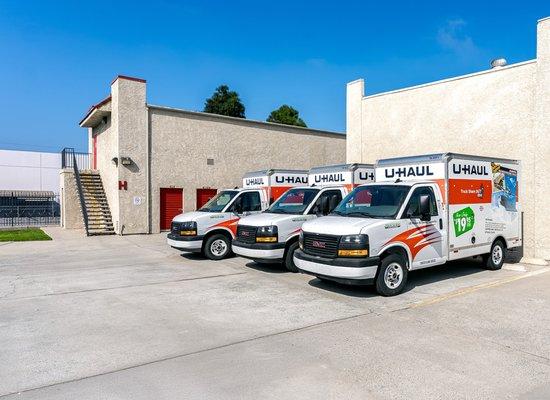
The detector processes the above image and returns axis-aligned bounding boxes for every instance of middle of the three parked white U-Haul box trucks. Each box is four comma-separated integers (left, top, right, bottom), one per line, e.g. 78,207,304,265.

233,164,374,272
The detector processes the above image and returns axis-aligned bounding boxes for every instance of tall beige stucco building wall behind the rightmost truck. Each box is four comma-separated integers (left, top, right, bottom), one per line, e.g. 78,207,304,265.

346,18,550,259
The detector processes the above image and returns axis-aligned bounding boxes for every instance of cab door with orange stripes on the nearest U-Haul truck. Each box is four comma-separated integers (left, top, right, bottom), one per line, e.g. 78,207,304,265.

403,185,447,269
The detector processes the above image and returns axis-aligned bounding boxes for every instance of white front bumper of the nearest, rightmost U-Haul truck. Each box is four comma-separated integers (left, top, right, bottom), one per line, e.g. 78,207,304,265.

294,250,380,285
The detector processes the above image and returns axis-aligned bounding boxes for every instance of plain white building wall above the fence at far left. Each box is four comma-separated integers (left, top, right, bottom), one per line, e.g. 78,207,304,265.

0,150,61,194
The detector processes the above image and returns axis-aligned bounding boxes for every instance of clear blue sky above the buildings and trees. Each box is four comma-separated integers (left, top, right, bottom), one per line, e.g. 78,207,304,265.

0,0,550,151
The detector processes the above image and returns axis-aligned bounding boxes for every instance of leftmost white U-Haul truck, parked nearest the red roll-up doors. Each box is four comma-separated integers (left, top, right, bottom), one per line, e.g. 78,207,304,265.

166,169,308,260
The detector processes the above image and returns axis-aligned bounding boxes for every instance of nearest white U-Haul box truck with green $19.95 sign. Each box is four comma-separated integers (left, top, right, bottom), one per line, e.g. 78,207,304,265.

294,153,522,296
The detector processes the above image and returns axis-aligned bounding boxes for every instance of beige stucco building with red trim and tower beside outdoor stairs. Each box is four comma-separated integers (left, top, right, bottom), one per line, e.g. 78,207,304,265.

80,76,346,234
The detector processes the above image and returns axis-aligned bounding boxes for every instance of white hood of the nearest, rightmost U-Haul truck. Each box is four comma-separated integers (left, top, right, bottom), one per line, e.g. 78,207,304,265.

302,216,389,235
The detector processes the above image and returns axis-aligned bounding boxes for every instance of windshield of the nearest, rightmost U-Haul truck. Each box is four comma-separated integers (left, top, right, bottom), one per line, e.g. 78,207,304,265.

332,185,410,219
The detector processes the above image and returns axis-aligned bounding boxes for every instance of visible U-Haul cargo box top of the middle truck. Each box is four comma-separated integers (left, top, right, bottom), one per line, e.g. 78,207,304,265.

309,164,374,191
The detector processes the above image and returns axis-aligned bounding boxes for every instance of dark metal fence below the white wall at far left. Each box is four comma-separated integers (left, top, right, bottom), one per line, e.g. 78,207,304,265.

0,190,61,228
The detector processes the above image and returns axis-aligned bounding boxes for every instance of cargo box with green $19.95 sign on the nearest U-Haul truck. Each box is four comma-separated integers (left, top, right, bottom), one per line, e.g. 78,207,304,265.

376,154,521,260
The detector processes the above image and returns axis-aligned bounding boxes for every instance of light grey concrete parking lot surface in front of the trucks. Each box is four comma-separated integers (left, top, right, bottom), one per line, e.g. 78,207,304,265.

0,228,550,399
